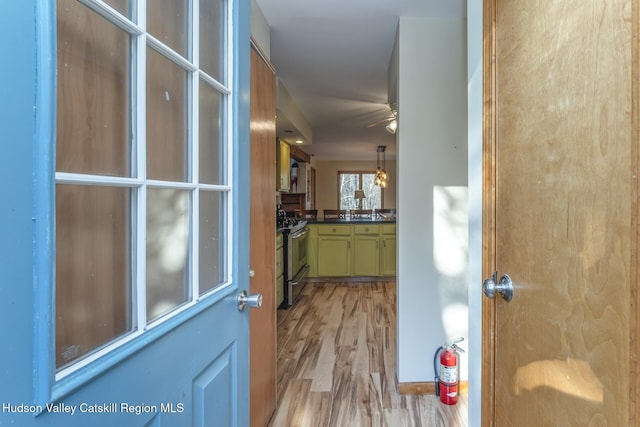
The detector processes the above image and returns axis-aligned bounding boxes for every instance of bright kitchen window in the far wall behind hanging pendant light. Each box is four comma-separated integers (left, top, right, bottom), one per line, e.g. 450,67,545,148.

338,171,383,210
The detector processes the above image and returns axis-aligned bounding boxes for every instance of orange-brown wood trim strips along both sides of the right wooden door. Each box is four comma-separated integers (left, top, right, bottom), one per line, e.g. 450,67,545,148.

482,0,640,427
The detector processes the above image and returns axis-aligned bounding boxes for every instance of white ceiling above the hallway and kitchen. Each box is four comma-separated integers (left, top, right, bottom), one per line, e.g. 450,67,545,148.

256,0,466,160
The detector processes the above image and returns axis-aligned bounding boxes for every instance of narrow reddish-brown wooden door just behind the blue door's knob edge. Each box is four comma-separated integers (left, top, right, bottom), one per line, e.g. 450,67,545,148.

251,44,276,426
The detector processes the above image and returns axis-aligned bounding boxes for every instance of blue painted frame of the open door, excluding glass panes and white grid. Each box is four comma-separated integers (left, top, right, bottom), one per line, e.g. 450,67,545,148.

0,0,250,427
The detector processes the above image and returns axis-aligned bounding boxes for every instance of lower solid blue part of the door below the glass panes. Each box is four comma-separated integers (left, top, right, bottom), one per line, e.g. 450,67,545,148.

0,289,248,427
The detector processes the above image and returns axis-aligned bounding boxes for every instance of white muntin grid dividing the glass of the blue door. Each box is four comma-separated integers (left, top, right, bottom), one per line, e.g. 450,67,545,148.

56,0,233,380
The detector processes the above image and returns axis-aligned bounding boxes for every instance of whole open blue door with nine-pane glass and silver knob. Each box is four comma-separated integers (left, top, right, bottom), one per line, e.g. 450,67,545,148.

0,0,254,426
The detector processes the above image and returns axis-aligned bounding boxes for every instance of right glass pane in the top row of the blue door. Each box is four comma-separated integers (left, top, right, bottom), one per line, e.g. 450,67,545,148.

200,0,227,84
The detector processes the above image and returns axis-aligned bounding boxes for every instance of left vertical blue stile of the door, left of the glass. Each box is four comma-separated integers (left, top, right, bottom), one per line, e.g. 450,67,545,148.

0,0,45,421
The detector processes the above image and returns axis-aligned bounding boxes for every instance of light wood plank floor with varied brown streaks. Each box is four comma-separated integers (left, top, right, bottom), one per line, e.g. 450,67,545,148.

269,281,467,427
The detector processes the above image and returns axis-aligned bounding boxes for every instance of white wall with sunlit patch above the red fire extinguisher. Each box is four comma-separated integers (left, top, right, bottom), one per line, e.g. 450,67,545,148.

393,17,468,382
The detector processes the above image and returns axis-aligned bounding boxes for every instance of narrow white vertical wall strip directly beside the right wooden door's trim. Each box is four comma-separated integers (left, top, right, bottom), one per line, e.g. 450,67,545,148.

467,0,483,427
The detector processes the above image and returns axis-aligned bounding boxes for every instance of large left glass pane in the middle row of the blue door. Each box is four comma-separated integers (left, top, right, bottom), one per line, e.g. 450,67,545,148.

56,0,131,176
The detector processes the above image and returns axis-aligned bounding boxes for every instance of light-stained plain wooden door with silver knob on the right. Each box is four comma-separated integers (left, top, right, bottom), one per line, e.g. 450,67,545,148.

482,0,638,426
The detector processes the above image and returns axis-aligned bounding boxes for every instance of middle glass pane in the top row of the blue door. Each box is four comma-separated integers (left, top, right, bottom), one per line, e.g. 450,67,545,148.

147,0,189,58
